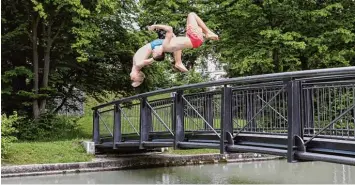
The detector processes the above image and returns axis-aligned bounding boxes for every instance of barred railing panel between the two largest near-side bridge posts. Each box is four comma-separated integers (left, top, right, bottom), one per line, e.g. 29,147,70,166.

233,82,288,135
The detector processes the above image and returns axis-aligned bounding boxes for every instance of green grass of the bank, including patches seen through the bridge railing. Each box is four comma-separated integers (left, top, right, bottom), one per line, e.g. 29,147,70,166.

2,93,258,165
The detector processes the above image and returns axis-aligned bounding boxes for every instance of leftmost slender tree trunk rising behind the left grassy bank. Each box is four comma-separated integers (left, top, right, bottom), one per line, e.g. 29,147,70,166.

31,15,40,120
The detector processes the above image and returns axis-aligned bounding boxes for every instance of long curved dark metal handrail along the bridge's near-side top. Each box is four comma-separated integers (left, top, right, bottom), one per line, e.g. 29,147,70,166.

92,66,355,110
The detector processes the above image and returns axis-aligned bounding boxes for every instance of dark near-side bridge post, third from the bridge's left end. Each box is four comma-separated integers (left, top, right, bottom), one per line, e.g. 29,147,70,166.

139,97,152,149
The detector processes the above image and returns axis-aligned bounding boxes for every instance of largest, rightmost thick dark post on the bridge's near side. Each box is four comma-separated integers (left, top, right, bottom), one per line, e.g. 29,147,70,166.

287,80,303,162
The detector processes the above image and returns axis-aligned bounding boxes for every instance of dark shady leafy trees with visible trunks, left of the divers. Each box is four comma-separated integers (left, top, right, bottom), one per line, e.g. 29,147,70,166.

2,0,140,118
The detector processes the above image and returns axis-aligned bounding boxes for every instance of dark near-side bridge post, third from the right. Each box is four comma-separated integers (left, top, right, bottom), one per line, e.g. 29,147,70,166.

173,91,185,149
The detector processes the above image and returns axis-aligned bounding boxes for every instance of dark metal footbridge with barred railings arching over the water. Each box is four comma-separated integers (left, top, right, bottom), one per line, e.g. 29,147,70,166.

93,67,355,165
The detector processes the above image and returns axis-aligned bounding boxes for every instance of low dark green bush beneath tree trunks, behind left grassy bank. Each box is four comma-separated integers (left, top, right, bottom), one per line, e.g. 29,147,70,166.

17,114,84,141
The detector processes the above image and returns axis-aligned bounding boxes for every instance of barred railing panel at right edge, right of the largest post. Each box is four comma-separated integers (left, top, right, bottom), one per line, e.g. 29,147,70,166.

303,80,355,142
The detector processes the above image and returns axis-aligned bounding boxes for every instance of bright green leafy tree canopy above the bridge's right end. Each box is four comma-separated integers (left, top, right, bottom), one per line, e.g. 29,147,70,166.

211,0,355,77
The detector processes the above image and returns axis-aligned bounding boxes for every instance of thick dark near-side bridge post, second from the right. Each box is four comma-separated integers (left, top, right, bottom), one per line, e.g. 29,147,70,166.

220,85,233,154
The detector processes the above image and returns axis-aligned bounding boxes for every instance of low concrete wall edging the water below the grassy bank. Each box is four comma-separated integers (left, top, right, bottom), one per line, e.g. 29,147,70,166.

1,153,280,178
